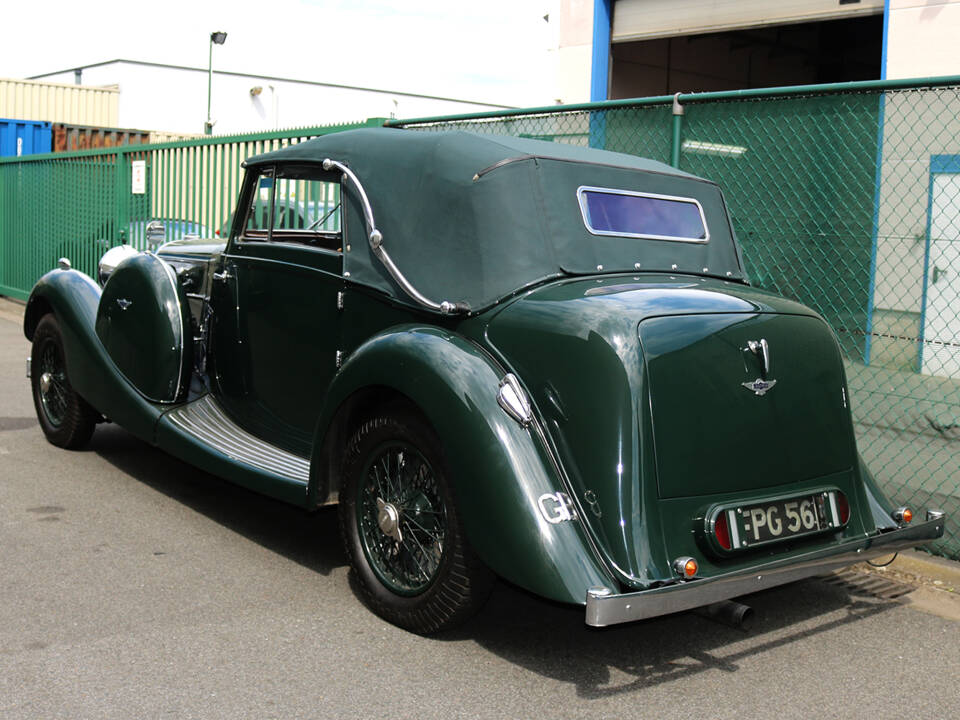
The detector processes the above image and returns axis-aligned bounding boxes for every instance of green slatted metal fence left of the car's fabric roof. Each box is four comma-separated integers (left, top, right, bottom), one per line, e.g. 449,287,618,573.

0,119,383,299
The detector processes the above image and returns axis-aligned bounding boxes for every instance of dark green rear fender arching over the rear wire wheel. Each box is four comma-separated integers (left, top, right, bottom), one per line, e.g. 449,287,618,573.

312,325,612,604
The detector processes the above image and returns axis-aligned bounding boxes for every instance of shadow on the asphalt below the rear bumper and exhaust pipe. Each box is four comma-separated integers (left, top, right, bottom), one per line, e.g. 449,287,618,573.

454,578,897,699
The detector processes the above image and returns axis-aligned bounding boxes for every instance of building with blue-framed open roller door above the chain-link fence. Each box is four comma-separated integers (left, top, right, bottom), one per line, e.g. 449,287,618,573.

551,0,960,103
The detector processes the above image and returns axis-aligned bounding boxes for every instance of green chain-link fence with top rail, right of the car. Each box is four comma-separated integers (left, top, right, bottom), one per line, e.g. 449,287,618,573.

390,78,960,559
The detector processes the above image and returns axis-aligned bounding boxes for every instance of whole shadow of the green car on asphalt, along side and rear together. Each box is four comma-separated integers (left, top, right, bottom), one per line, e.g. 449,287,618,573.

89,426,897,699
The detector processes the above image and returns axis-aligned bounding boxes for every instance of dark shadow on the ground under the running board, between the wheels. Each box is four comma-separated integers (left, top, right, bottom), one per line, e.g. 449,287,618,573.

88,425,347,575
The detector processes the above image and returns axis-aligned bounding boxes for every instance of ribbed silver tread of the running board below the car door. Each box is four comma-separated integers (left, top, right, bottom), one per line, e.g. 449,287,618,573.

165,395,310,484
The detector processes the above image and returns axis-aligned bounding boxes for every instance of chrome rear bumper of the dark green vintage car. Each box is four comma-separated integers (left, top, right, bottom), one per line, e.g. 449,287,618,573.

586,510,945,627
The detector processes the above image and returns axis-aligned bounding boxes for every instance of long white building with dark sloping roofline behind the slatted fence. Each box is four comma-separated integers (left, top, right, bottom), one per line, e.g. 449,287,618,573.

35,62,510,135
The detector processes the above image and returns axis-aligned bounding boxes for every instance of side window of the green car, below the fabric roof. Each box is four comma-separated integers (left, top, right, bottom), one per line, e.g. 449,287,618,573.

243,166,342,252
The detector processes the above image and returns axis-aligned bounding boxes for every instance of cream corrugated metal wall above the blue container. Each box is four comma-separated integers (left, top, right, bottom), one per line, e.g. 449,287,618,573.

0,78,120,127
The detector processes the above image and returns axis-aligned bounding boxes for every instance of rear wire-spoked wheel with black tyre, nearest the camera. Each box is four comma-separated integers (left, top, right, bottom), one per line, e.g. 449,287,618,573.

340,414,493,634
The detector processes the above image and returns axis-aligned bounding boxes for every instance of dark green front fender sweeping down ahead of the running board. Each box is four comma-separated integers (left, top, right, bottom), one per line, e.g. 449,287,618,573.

23,270,160,443
